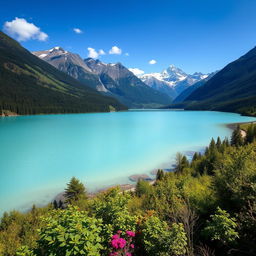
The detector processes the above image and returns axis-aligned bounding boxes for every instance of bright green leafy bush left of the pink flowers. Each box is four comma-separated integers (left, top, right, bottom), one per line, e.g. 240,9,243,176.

37,206,104,256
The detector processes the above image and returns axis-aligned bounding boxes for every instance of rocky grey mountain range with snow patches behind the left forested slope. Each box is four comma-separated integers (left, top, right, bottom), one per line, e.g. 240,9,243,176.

33,47,172,108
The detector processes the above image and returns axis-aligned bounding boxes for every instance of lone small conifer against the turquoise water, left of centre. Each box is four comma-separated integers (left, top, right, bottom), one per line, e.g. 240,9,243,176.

64,177,87,204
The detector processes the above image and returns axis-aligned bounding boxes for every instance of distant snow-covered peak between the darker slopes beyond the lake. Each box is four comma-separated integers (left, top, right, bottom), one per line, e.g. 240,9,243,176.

139,65,208,99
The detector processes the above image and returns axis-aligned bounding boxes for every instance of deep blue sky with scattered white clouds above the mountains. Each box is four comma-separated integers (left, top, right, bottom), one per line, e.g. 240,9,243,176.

0,0,256,73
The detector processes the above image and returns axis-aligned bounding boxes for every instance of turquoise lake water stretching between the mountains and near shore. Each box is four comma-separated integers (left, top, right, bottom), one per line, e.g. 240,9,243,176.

0,111,255,213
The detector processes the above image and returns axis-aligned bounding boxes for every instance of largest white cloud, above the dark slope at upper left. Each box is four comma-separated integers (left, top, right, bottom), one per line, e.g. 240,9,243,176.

3,17,48,41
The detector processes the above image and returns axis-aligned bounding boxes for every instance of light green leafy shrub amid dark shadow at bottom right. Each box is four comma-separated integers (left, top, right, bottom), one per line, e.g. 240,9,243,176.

203,207,239,245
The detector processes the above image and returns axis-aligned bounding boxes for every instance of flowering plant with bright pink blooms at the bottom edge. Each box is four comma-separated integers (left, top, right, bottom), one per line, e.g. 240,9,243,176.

109,230,135,256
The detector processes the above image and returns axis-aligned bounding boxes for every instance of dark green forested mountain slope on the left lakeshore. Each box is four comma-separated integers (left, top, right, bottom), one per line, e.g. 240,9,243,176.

0,31,125,115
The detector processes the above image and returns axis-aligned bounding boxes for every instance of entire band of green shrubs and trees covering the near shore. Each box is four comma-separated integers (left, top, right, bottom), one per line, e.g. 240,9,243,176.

0,131,256,256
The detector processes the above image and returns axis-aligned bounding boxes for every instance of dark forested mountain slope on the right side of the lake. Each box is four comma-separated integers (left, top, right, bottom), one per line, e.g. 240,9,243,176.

186,47,256,115
